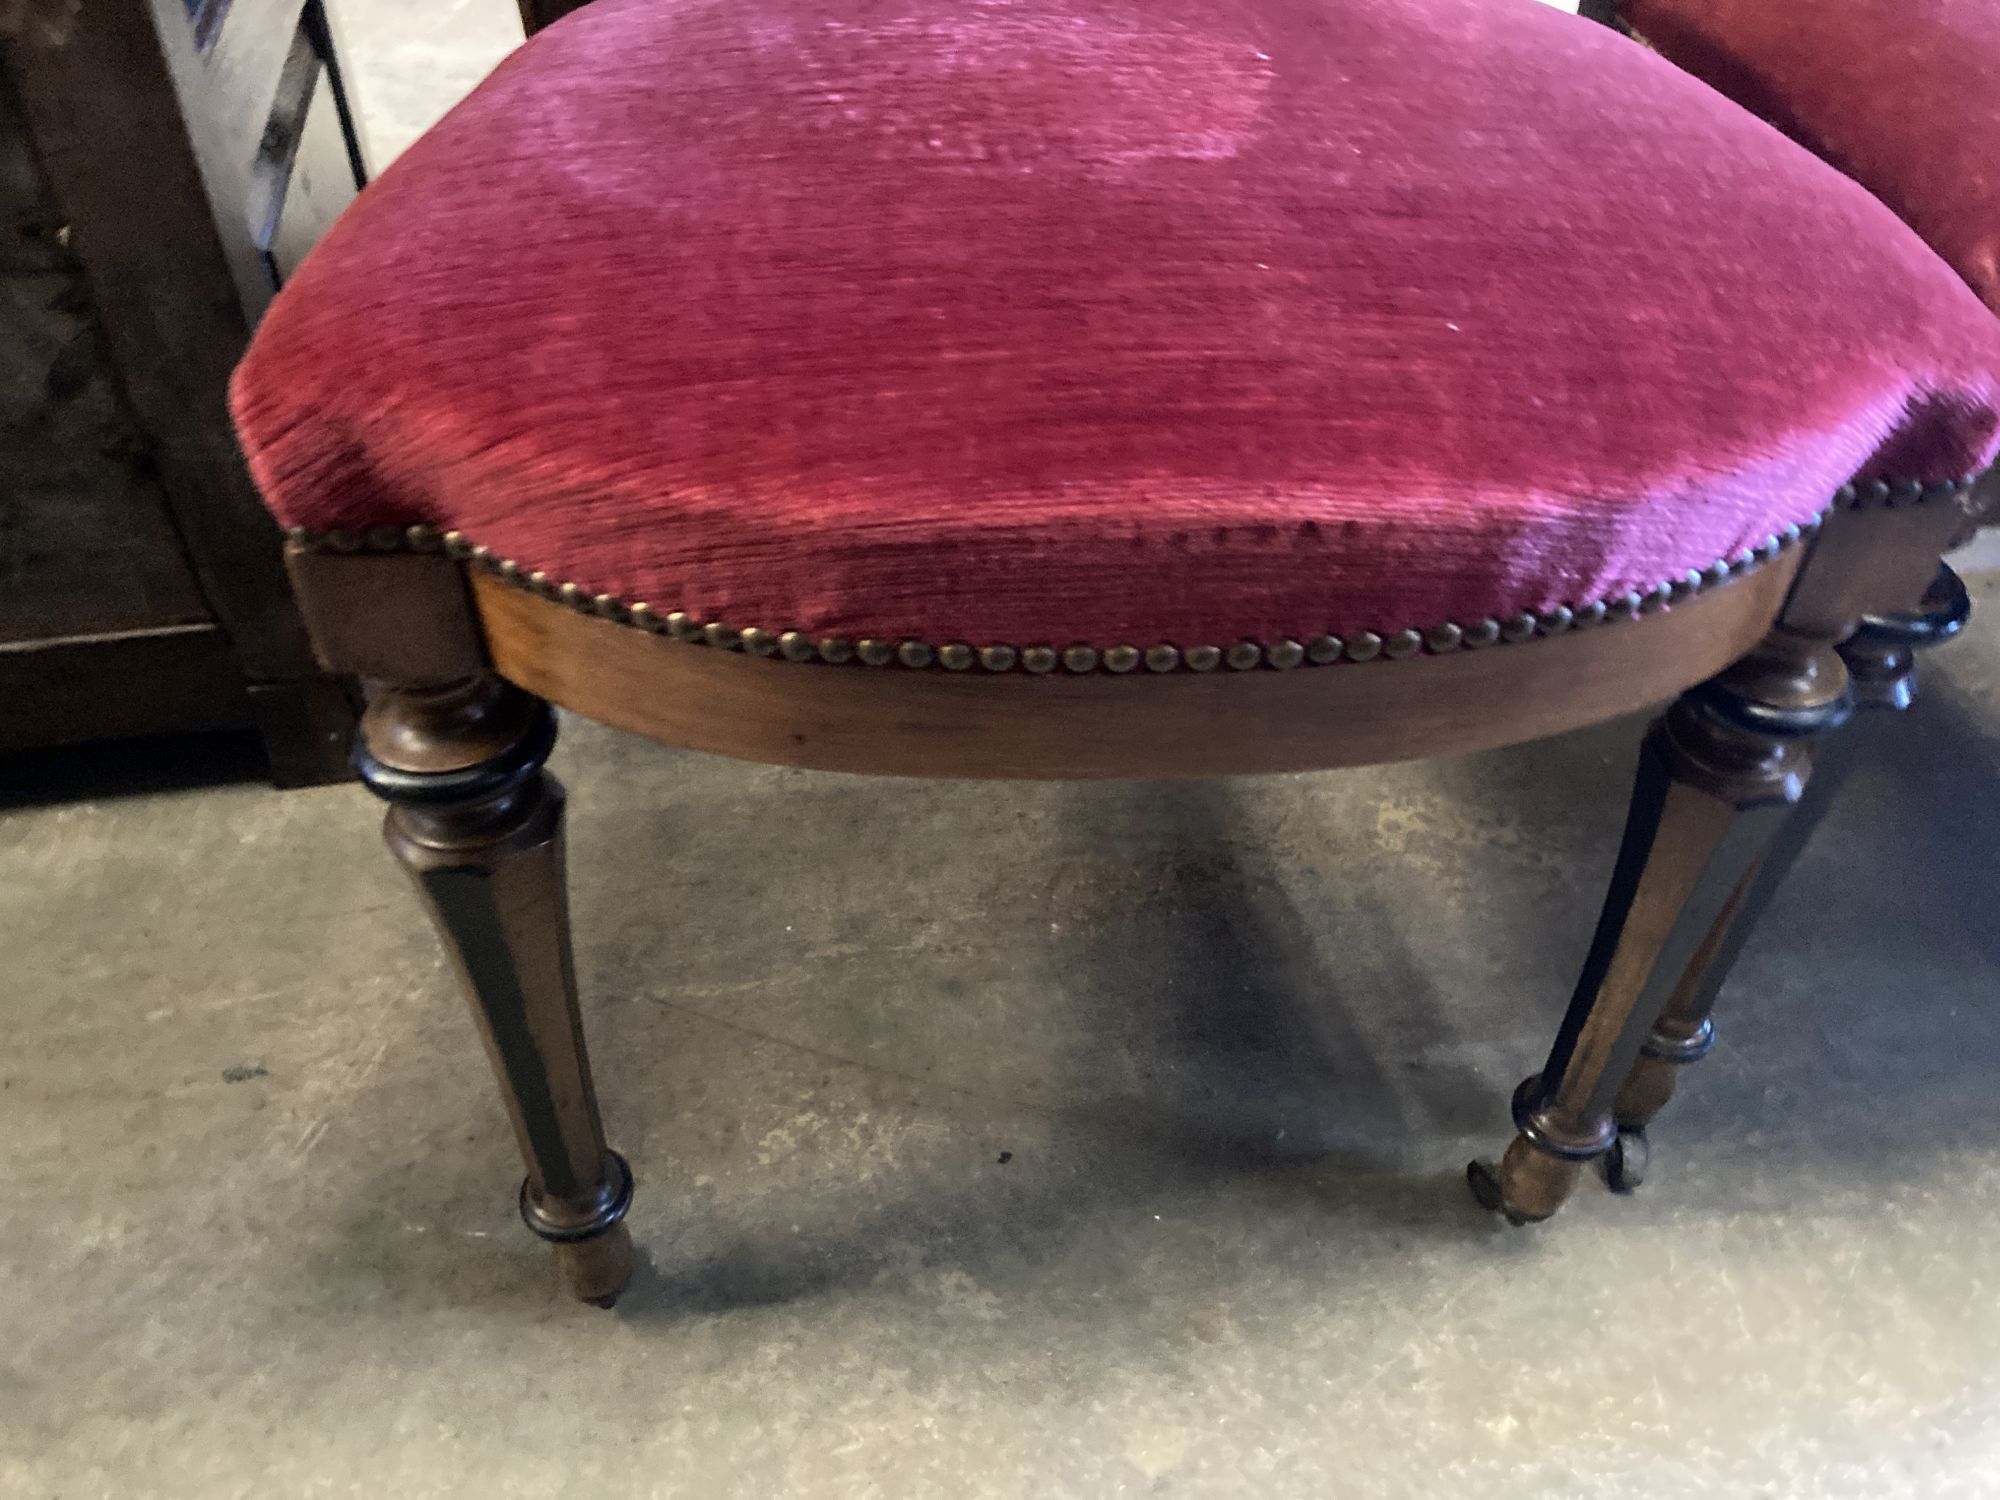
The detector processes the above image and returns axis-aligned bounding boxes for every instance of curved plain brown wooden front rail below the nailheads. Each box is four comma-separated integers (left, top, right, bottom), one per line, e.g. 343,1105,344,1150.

472,556,1796,778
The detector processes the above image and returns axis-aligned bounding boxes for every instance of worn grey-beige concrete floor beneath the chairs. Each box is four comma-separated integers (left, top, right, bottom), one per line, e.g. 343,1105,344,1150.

0,574,2000,1500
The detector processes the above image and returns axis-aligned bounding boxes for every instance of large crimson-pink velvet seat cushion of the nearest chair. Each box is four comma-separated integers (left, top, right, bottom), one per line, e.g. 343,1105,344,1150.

236,0,2000,646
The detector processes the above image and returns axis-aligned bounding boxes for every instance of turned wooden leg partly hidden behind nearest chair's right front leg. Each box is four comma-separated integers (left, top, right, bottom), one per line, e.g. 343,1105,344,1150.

1604,566,1972,1192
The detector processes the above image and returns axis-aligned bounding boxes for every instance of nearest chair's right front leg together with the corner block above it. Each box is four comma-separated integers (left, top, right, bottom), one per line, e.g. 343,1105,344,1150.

1466,482,1968,1224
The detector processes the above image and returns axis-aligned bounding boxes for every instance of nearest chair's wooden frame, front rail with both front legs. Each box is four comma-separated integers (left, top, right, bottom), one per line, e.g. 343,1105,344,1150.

270,470,1970,1304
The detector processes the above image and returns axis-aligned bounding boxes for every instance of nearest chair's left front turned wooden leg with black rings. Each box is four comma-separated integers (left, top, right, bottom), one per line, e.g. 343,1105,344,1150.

360,678,632,1308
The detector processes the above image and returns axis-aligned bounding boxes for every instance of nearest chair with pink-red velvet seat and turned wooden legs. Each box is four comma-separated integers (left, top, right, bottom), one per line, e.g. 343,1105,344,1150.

234,0,2000,1304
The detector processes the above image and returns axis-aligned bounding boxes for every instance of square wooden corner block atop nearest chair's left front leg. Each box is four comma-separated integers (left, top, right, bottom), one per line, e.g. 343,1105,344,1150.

284,544,488,688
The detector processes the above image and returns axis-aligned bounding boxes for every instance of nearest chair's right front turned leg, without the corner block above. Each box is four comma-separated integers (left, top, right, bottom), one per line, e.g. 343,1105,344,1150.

1468,626,1850,1224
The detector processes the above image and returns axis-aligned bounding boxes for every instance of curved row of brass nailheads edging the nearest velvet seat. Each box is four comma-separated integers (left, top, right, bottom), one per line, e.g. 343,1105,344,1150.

286,474,1980,676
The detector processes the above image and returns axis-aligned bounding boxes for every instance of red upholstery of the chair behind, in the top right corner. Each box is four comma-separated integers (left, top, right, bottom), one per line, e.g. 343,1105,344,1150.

1626,0,2000,310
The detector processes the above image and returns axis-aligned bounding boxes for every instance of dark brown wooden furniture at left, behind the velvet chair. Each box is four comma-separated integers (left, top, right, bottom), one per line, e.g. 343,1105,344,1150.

0,0,362,784
